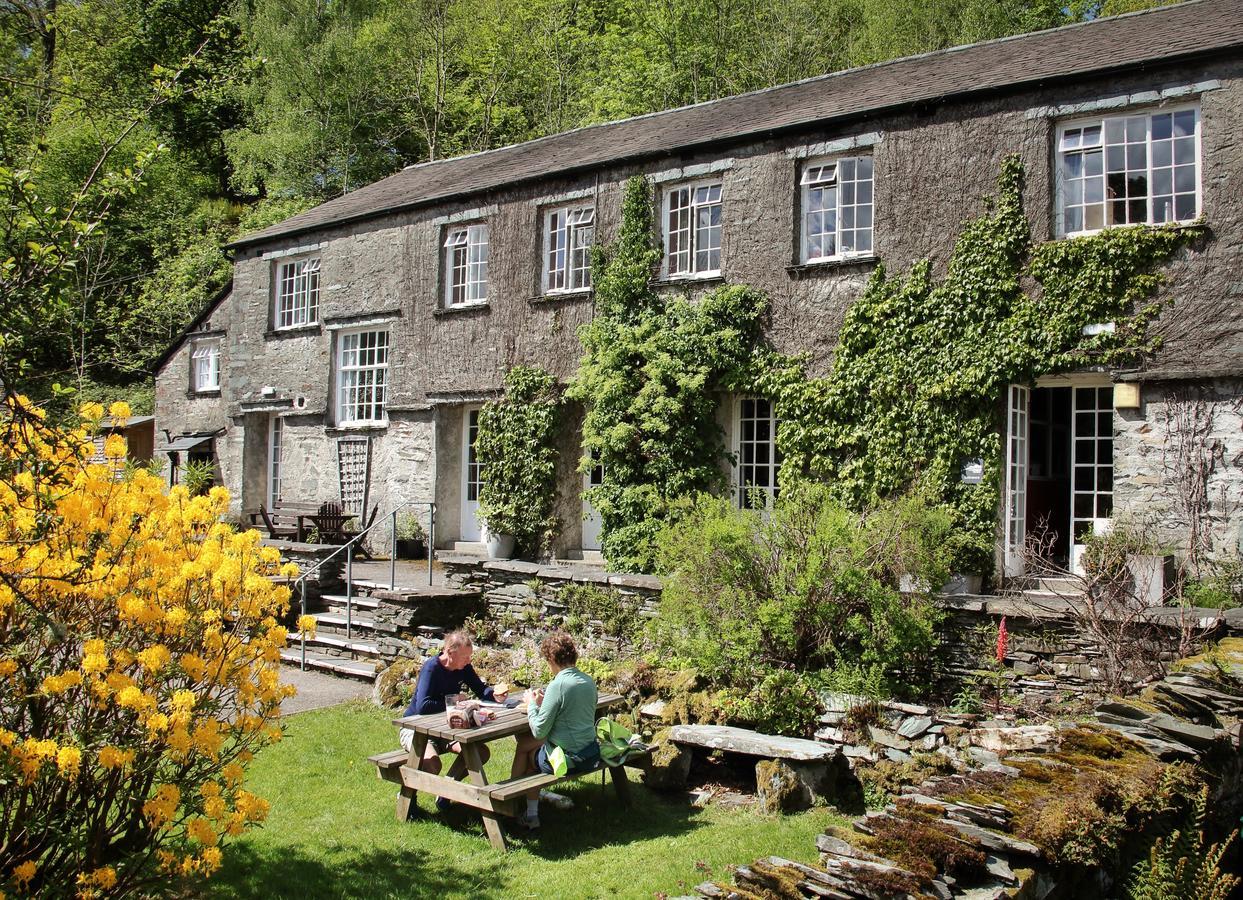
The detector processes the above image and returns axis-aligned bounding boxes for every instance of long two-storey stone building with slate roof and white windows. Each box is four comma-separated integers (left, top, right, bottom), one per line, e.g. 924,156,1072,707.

157,0,1243,571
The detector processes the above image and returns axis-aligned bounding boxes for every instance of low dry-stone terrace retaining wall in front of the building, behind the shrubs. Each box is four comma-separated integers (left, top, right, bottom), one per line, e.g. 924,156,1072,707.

438,553,1243,694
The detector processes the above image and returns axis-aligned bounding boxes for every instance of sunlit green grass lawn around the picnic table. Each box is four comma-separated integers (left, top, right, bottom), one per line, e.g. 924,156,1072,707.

209,702,846,900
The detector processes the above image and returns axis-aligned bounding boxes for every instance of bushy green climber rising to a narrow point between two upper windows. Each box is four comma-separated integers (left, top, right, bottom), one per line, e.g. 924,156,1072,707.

568,178,767,571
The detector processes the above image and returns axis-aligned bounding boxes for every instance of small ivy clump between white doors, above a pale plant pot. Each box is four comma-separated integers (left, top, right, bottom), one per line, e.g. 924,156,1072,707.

475,365,562,552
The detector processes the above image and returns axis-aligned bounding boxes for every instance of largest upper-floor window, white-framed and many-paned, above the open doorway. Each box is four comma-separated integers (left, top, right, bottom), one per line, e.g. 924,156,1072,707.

1057,107,1201,235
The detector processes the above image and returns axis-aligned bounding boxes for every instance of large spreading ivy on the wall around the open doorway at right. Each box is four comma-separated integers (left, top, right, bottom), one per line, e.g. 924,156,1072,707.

753,157,1199,572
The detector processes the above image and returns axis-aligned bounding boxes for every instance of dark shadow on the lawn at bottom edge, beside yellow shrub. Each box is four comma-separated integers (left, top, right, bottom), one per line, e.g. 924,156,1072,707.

215,845,501,900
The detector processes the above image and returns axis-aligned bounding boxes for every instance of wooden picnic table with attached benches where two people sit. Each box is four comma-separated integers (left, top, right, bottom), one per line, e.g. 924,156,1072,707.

370,694,625,852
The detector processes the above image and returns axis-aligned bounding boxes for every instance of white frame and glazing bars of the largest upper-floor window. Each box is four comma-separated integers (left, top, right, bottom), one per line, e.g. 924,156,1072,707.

1053,103,1203,237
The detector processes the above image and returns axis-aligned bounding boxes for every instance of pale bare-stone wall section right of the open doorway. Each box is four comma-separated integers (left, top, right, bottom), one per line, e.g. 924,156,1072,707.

1114,379,1243,558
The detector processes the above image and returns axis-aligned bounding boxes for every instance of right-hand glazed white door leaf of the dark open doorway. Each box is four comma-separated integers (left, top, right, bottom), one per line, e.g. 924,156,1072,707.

1070,384,1114,574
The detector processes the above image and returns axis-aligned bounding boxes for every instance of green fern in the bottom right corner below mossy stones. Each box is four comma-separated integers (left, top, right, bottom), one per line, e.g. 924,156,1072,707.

1126,787,1241,900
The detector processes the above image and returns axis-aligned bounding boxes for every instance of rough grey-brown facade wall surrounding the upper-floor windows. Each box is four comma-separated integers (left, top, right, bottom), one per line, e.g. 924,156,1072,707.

157,61,1243,551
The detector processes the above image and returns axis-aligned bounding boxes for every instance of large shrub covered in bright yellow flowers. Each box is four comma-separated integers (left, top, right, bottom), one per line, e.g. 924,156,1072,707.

0,398,296,898
